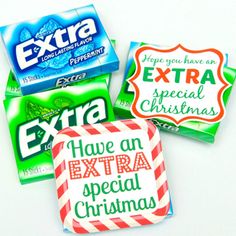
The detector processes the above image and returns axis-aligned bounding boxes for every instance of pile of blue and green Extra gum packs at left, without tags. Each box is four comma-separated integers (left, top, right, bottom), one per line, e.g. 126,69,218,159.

1,5,119,184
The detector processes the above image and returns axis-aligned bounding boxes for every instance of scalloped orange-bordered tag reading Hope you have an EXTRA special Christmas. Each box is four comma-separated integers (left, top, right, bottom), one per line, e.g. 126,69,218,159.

128,45,229,125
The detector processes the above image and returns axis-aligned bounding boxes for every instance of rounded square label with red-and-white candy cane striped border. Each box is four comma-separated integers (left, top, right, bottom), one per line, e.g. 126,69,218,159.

52,119,170,234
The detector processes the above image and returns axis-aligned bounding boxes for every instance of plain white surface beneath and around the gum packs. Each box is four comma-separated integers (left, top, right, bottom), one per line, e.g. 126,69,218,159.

0,0,236,236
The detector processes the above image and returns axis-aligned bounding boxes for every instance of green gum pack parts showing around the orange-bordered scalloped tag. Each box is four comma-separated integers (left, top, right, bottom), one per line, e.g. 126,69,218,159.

114,42,236,143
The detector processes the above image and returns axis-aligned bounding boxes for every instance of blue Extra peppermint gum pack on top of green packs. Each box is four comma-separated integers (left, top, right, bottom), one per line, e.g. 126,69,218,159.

1,5,119,95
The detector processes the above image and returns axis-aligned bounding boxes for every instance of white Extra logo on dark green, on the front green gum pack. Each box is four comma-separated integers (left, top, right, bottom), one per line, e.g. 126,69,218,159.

17,98,108,160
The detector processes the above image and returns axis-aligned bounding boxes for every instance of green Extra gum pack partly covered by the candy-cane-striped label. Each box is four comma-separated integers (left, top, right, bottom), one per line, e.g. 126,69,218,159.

4,79,114,184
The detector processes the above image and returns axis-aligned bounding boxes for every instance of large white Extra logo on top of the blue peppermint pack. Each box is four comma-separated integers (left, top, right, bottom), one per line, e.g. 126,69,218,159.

15,18,97,70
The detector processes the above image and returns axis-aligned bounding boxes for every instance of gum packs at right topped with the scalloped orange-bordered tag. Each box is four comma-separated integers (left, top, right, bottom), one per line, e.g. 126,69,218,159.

114,42,236,143
